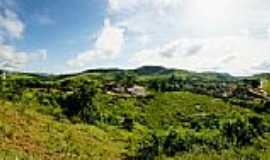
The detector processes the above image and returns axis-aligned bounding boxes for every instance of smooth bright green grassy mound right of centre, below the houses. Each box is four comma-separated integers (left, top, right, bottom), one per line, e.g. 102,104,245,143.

144,92,251,129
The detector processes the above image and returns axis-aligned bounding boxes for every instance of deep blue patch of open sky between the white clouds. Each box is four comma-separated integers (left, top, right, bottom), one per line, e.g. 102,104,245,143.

3,0,106,72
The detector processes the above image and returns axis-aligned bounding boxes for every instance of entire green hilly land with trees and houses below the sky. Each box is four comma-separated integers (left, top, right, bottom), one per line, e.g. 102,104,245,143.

0,67,270,160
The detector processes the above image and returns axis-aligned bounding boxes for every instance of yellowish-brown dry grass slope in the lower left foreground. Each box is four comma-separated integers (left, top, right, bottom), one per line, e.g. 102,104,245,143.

0,102,125,160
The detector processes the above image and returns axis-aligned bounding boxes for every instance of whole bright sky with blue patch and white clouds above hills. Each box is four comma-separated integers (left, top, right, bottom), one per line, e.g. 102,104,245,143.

0,0,270,75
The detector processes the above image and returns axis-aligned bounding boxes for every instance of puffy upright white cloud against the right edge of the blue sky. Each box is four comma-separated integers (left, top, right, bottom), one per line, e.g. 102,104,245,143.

67,20,125,67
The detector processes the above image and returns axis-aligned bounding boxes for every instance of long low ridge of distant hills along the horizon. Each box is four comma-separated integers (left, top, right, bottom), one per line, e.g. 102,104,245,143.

0,65,270,80
